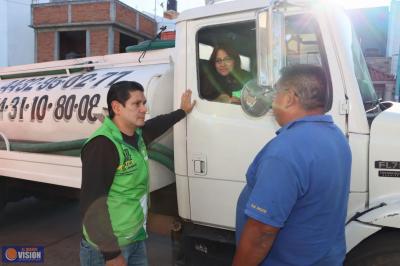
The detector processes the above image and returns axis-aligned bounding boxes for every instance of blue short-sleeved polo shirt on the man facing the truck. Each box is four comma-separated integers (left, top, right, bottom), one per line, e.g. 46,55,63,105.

236,115,351,266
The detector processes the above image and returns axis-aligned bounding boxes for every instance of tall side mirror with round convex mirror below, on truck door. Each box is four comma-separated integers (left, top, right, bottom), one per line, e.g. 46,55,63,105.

240,4,286,117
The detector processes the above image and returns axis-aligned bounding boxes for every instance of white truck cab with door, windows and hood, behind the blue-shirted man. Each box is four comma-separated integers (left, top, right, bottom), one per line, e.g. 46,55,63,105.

174,0,400,265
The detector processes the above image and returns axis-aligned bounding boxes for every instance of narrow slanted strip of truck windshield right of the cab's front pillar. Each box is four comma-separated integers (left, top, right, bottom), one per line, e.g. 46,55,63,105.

351,29,380,115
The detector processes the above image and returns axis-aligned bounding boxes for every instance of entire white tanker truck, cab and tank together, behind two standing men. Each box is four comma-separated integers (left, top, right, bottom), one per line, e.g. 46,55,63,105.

0,0,400,265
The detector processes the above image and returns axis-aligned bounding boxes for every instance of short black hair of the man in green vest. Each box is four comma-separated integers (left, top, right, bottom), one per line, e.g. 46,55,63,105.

107,81,144,119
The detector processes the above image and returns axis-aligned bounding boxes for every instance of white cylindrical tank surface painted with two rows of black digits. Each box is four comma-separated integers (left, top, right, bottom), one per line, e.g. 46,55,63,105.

0,63,173,142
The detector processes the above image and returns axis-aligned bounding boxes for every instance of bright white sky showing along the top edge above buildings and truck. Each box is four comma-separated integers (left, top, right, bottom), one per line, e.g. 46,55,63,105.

121,0,390,16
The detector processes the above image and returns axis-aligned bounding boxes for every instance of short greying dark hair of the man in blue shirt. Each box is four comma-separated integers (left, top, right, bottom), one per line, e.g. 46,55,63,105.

277,64,330,111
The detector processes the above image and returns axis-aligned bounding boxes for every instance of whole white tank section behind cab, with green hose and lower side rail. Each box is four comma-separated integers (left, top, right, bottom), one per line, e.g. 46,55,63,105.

0,49,175,191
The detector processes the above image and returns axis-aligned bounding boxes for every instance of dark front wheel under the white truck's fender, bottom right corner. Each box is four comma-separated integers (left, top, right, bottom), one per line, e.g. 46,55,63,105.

344,229,400,266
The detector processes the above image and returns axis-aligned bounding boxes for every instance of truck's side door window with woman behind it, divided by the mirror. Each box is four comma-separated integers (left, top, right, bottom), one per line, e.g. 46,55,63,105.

197,14,332,108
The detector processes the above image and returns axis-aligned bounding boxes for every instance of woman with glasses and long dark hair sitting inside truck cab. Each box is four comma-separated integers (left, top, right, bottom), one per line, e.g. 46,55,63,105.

200,44,252,104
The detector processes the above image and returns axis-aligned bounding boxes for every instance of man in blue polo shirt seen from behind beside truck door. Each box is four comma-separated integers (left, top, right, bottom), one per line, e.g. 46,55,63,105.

233,65,351,266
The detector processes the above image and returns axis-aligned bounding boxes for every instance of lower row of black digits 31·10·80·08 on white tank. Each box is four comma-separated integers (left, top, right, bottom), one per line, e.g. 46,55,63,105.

0,94,100,123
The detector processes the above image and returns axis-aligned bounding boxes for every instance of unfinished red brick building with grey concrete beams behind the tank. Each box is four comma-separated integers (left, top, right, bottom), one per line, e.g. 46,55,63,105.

32,0,156,62
